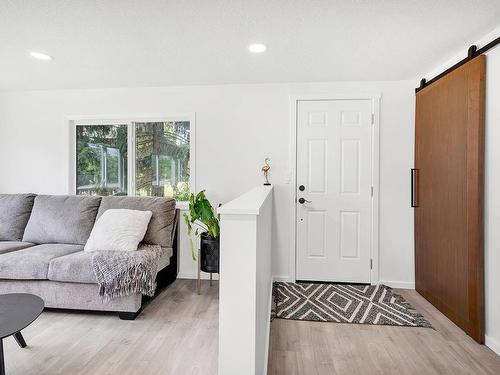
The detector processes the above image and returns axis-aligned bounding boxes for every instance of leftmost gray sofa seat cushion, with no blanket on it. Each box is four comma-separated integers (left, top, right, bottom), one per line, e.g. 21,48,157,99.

0,244,83,280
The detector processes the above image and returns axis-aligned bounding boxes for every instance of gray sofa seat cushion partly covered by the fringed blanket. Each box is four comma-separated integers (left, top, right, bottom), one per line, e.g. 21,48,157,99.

47,248,173,284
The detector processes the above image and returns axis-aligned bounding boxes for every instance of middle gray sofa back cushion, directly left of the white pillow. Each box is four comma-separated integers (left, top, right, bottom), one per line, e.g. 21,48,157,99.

23,195,101,245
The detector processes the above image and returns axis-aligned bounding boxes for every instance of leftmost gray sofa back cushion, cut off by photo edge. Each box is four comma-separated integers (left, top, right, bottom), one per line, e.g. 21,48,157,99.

0,194,35,241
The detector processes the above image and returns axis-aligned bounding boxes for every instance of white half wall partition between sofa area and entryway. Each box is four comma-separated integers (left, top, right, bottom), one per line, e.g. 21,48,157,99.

219,186,273,375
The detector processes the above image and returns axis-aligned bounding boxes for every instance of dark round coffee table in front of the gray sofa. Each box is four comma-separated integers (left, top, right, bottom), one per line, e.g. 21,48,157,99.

0,293,44,375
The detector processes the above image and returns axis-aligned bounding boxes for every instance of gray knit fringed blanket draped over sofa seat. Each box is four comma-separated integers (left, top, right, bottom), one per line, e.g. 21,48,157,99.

92,244,162,302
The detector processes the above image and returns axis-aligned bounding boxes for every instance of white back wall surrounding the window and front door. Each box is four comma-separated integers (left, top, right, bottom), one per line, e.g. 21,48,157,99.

0,81,414,287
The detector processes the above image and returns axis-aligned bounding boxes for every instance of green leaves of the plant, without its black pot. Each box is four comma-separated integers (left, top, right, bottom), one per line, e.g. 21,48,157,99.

184,190,220,261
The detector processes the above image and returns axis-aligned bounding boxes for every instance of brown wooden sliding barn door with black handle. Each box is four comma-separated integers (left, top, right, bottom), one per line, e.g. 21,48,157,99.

412,55,484,343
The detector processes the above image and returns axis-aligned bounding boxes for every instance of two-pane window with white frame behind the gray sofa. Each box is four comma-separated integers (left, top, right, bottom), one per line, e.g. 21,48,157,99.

71,115,195,201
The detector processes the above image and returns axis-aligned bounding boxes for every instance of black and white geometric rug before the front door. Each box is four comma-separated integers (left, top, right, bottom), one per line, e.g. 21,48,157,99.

273,282,432,328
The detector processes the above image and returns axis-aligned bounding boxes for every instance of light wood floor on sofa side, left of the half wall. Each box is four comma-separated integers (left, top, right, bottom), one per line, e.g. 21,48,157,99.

4,280,219,375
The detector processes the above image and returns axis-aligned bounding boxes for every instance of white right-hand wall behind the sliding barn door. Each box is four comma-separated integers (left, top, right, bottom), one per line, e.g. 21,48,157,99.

423,27,500,355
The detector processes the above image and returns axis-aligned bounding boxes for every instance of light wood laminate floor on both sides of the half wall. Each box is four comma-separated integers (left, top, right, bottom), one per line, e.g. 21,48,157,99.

4,280,500,375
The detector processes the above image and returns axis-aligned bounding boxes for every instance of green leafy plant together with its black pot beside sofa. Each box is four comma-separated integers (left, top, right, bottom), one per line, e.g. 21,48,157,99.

184,190,220,273
